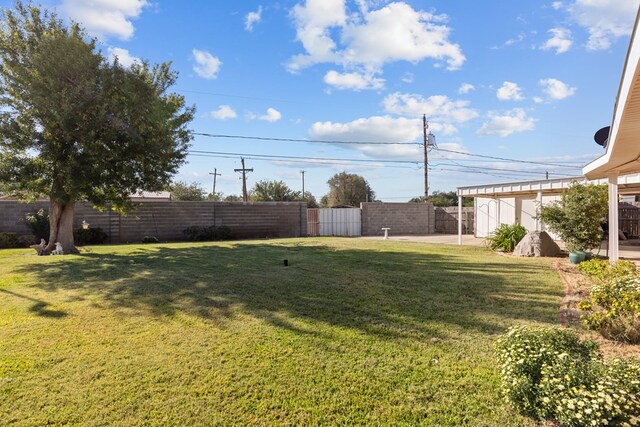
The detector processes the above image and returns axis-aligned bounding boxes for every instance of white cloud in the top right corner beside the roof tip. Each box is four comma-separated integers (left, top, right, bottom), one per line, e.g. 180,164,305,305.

567,0,638,50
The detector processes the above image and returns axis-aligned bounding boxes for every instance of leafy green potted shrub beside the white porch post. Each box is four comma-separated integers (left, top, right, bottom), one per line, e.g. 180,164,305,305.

539,182,608,252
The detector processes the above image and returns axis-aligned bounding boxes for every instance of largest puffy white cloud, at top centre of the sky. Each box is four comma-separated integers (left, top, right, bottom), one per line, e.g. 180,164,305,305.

287,0,465,78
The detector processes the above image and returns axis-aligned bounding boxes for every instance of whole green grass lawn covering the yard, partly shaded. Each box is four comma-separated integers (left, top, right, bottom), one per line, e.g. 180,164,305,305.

0,238,563,426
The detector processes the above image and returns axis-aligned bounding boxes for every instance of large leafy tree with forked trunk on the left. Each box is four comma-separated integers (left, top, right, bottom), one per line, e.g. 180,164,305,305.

0,3,194,252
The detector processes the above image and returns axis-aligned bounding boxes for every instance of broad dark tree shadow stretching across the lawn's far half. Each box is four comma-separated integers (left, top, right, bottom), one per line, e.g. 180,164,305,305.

15,243,561,339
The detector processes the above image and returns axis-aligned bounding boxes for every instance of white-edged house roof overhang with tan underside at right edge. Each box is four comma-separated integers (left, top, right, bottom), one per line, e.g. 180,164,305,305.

582,7,640,179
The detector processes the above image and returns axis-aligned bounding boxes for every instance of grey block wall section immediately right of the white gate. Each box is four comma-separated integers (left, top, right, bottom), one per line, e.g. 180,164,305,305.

360,202,435,236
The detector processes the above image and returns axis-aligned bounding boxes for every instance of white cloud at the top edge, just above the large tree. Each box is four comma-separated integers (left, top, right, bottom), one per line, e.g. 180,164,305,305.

60,0,149,40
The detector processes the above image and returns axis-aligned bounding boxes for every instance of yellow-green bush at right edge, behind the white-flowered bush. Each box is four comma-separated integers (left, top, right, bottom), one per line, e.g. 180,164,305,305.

578,274,640,344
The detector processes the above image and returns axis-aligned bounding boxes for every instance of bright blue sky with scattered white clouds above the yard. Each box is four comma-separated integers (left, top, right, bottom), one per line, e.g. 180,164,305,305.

17,0,639,201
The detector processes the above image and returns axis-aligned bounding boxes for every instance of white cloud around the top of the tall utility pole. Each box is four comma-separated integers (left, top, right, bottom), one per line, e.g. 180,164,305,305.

382,92,478,135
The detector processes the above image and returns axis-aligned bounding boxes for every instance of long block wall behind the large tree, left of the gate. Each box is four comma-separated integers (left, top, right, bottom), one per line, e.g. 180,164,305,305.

0,200,307,243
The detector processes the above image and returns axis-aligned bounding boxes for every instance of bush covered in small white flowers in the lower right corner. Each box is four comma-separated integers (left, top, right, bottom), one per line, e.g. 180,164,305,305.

496,327,640,427
